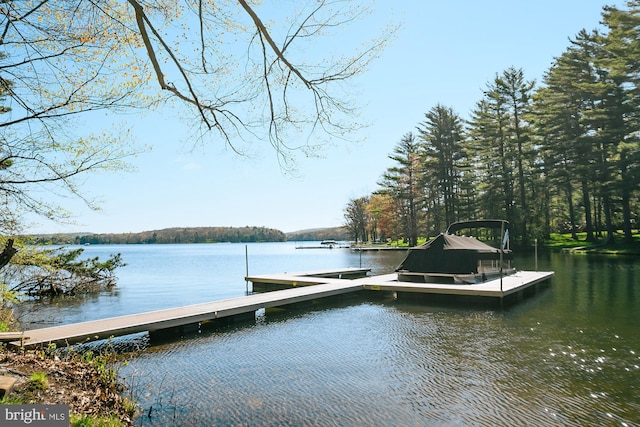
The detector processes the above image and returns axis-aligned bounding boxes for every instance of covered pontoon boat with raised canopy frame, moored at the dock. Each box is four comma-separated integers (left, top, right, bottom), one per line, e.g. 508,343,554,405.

396,219,516,284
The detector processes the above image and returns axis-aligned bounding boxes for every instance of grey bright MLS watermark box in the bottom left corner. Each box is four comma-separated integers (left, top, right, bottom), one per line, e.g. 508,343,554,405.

0,405,69,427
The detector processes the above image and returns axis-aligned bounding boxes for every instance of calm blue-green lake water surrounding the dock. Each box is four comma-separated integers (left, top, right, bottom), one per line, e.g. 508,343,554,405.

15,242,640,426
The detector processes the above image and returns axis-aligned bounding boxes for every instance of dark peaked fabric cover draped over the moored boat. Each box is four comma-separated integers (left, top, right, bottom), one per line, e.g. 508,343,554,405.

396,234,513,274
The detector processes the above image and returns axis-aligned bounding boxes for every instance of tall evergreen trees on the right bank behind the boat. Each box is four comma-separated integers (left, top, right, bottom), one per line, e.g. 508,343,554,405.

344,0,640,245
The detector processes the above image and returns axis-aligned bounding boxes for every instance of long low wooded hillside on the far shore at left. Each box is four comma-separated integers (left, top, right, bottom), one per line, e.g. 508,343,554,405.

31,227,286,245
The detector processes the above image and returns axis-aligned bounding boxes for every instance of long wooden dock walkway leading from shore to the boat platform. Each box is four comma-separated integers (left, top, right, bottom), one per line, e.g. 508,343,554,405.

12,269,553,347
